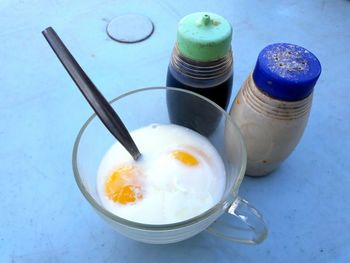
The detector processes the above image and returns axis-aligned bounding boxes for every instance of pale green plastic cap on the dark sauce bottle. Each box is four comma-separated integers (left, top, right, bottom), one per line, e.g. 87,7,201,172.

177,12,232,61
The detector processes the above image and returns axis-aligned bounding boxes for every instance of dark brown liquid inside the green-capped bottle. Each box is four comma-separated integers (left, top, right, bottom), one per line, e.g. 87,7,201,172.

166,70,232,136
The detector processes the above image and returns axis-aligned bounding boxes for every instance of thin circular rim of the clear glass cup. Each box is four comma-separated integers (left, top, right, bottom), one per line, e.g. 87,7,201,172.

72,87,247,230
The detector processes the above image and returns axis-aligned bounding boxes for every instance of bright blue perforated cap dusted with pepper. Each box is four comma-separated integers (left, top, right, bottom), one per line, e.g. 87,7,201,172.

253,43,321,101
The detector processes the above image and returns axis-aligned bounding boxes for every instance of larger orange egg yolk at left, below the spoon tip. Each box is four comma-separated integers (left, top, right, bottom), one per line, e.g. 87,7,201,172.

105,165,143,205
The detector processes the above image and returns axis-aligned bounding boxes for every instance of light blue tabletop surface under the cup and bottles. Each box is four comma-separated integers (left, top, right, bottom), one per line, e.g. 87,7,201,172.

0,0,350,263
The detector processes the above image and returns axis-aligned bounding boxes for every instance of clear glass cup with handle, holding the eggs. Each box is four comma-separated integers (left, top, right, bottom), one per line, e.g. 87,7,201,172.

72,87,267,244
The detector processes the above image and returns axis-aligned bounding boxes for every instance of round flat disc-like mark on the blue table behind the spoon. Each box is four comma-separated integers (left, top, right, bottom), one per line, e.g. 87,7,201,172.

107,14,154,43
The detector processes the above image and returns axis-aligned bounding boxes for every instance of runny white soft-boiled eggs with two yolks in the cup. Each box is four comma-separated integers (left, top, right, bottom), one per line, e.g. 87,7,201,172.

97,124,225,224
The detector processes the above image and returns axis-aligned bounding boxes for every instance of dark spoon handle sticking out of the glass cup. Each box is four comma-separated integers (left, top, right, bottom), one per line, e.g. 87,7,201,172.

42,27,141,161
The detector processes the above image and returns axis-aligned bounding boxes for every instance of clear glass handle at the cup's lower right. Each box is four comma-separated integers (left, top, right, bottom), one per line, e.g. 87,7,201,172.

207,197,267,244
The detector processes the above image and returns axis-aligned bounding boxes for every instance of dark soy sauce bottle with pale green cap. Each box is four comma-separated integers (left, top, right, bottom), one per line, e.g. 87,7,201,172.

166,12,233,132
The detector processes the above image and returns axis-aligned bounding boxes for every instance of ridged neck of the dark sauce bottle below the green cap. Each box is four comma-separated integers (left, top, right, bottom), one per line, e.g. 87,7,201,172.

169,46,233,87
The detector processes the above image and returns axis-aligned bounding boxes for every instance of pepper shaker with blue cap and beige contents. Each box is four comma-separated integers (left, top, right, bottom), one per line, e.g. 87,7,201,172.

230,43,321,176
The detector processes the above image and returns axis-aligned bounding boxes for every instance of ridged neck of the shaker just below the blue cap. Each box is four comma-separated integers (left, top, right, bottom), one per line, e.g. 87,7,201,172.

241,74,312,120
